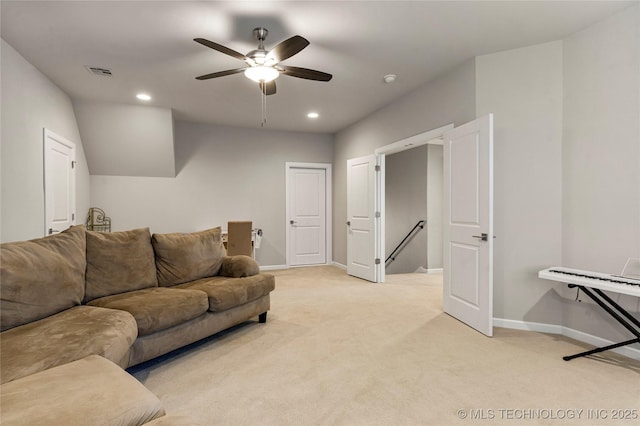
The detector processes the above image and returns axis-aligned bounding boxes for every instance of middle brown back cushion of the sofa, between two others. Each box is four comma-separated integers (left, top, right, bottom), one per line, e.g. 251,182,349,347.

84,228,158,303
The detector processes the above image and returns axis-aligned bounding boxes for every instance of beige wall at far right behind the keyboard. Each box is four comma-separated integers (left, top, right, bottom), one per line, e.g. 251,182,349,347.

562,6,640,341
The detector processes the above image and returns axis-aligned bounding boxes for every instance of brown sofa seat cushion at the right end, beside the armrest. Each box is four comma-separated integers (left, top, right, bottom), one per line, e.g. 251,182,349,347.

176,274,276,312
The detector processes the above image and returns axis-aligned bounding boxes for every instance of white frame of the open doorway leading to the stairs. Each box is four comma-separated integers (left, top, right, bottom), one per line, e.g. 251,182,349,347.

374,123,454,283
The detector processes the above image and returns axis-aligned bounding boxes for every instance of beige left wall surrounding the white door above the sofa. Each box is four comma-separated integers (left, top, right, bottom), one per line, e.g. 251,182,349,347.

0,40,89,242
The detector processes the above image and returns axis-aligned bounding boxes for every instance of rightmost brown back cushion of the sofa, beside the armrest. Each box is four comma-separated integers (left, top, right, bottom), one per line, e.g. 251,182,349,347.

151,227,226,287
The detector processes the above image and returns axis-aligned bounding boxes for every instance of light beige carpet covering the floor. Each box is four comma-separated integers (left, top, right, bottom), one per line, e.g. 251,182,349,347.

130,266,640,425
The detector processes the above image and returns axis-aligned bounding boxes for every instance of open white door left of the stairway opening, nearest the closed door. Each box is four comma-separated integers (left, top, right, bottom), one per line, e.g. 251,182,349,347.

347,155,380,282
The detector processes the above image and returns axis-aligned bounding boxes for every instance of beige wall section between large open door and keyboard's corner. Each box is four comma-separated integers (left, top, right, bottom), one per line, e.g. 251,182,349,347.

476,41,562,323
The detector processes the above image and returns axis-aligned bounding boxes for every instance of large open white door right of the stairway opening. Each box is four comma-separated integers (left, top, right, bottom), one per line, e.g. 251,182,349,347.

443,115,493,336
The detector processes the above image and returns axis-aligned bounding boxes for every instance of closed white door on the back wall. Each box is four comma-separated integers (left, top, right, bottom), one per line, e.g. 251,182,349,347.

288,167,327,266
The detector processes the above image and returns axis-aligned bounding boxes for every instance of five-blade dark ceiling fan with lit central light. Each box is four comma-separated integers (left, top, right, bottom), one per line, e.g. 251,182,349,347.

193,27,333,95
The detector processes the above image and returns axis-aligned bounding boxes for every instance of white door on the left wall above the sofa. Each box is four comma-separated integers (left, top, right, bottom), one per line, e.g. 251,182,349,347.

44,129,76,235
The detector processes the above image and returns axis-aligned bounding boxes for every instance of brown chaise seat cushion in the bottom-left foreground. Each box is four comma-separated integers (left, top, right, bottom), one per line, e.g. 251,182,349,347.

1,355,164,426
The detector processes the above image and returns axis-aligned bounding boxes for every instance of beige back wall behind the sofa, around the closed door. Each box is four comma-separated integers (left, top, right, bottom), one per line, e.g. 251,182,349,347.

91,121,333,266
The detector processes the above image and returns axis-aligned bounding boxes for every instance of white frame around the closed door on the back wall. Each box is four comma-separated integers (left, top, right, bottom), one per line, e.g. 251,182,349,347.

284,161,333,268
